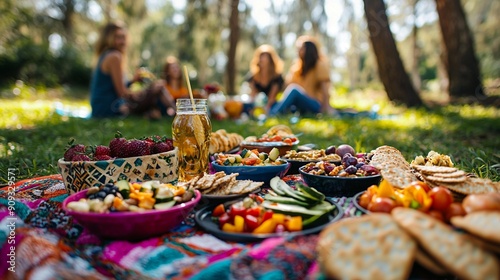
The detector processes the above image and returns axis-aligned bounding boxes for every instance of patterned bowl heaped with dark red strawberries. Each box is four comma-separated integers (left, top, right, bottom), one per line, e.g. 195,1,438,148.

57,133,178,194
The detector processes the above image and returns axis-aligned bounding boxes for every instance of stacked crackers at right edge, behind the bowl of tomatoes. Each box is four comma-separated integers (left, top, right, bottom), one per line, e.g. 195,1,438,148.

411,165,500,195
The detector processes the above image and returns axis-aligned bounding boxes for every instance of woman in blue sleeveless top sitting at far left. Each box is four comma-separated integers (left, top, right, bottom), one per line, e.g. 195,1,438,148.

90,22,175,119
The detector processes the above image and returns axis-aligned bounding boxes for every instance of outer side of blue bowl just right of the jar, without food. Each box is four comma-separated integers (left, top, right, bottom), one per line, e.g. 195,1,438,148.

212,161,290,184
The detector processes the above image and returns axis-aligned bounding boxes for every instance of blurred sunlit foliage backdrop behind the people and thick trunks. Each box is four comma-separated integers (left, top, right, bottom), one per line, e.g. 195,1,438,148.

0,0,500,105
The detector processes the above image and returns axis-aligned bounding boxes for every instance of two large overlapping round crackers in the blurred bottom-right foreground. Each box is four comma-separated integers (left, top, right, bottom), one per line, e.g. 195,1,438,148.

317,207,500,279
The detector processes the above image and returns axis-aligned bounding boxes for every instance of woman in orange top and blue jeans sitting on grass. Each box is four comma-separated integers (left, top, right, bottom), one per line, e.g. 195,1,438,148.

270,36,336,115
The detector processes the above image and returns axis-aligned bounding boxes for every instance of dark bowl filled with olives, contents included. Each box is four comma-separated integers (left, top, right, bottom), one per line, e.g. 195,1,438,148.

299,153,382,197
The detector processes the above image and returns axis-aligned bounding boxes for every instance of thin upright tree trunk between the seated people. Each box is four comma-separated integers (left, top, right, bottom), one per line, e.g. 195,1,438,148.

226,0,240,95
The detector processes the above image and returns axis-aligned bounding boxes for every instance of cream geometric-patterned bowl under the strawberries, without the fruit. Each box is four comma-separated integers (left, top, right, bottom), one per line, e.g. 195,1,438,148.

57,148,179,194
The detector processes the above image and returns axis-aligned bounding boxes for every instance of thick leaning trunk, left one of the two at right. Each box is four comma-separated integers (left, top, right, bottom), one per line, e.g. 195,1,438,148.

363,0,422,107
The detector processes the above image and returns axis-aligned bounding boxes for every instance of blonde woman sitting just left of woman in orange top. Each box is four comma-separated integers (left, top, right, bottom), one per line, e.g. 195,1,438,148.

247,44,284,114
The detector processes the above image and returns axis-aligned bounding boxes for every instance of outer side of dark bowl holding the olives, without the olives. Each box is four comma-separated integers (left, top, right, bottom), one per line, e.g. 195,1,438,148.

299,167,382,197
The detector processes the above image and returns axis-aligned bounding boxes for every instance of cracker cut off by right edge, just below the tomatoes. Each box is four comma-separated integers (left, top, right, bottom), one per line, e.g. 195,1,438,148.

451,211,500,245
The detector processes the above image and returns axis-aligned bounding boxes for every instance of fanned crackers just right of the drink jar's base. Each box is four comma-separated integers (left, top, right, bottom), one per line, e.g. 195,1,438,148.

181,171,264,195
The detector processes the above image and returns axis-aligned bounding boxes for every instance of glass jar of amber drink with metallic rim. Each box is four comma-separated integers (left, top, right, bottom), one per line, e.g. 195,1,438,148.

172,99,212,181
